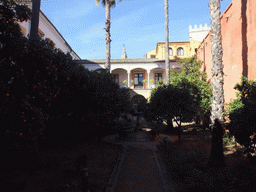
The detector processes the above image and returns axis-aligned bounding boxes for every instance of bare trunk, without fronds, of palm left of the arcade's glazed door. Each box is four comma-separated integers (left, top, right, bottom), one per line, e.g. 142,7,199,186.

105,0,111,72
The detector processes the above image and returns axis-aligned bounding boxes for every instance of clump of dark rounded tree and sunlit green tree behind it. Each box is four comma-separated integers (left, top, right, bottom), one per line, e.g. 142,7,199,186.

145,57,212,134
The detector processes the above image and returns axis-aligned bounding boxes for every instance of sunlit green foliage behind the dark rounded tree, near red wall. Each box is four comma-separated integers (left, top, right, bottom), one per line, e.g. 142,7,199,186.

171,56,212,124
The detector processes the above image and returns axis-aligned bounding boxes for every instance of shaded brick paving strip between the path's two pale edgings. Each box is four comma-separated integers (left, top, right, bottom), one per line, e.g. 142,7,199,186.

114,145,165,192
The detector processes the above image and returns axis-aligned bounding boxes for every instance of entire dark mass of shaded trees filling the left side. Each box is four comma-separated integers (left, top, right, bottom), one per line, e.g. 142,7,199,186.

0,0,131,154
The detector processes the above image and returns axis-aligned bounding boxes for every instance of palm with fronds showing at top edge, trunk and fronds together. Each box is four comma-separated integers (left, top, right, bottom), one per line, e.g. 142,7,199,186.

96,0,122,72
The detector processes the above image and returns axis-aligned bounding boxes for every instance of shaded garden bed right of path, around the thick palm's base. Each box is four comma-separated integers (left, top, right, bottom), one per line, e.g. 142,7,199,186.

157,126,256,192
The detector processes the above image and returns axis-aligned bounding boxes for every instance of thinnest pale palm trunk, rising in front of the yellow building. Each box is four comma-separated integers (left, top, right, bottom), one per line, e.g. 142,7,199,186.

164,0,170,84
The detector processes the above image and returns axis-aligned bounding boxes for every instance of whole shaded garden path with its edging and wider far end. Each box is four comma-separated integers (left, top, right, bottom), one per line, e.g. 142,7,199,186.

106,120,173,192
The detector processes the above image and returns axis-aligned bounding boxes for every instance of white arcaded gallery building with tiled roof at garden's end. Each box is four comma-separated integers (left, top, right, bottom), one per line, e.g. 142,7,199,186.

77,59,182,99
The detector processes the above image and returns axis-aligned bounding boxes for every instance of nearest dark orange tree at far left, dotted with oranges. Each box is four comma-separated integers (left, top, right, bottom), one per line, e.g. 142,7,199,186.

0,0,75,149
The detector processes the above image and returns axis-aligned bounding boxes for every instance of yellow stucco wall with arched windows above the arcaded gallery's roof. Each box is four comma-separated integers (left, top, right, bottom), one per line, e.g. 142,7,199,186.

146,40,200,60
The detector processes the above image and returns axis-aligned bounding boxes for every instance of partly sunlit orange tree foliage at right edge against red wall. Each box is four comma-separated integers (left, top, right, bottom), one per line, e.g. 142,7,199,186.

226,77,256,153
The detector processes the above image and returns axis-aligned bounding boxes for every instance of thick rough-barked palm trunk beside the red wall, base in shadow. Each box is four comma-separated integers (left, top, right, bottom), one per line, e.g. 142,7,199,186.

208,0,225,166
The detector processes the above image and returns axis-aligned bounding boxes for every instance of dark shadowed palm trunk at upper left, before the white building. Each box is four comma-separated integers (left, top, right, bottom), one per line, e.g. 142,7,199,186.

29,0,41,39
